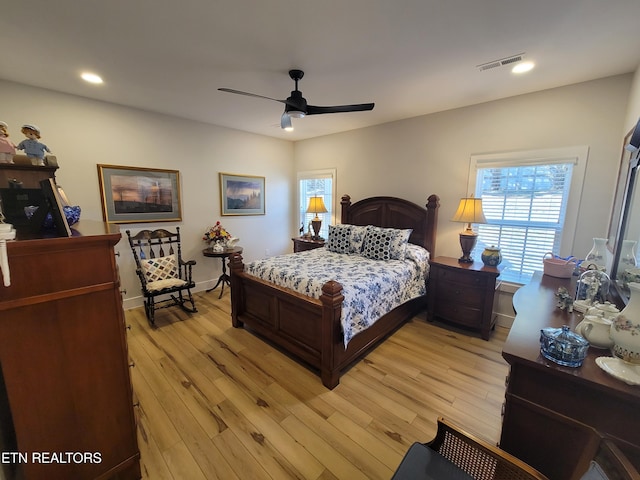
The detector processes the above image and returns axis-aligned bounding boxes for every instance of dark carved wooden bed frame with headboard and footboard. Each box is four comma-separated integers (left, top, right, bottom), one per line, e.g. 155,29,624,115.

229,195,440,389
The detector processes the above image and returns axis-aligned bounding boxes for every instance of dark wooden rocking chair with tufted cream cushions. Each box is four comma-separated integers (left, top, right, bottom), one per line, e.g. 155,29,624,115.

127,227,198,327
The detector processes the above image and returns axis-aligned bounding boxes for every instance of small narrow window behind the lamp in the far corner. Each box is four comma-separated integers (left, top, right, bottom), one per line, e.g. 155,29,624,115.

298,169,336,238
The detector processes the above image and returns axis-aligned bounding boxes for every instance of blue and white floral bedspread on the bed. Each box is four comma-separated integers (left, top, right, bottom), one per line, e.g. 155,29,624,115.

245,245,429,347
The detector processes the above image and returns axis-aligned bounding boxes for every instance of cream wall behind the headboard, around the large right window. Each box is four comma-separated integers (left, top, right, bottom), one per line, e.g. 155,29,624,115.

295,75,632,267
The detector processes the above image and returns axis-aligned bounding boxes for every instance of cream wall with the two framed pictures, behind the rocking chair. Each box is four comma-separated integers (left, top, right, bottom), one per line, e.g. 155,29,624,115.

0,81,295,307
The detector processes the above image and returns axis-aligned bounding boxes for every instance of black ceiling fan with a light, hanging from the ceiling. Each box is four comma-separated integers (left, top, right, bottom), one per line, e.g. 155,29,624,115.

218,70,374,129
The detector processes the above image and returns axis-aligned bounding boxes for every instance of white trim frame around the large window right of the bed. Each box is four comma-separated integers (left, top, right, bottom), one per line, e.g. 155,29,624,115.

468,145,589,283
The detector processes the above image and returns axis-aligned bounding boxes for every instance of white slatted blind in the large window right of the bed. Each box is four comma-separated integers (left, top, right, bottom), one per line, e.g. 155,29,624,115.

474,159,576,283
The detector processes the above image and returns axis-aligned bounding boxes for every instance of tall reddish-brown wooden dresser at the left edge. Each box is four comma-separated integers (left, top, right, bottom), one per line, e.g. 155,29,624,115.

0,221,140,480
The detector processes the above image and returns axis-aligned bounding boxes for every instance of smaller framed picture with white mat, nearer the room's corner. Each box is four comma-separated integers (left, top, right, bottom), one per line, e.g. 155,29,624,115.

220,173,265,215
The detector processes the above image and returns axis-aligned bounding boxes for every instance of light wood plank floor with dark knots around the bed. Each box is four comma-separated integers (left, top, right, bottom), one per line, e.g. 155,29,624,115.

126,291,507,480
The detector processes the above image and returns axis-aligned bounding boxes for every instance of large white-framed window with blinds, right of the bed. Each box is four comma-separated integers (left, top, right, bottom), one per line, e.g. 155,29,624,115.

472,147,588,283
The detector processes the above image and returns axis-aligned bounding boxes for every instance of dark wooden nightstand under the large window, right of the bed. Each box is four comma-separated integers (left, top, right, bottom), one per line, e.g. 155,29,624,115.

427,257,502,340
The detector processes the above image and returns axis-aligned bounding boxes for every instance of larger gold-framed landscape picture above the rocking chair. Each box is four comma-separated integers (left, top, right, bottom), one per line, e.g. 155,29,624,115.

98,165,182,223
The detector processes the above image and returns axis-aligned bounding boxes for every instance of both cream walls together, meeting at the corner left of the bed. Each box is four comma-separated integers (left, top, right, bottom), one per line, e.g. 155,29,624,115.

0,73,640,318
